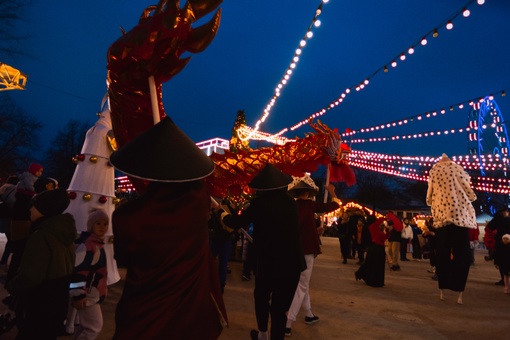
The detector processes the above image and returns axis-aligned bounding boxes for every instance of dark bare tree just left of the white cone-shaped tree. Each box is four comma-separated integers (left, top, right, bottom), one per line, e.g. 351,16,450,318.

44,120,91,188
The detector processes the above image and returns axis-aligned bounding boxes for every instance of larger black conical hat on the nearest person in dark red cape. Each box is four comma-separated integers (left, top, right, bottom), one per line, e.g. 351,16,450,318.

110,116,214,182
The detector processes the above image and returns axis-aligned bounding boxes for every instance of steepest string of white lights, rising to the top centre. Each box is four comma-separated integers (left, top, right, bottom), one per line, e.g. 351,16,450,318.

240,0,329,140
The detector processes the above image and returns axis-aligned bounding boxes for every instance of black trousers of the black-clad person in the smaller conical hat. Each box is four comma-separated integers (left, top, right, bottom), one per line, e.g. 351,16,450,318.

253,272,301,340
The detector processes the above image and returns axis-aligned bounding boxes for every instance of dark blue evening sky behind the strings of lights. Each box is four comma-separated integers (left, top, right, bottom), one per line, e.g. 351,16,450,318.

3,0,510,156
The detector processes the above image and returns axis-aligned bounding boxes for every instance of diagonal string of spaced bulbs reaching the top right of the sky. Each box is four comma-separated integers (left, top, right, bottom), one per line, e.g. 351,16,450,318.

282,0,485,132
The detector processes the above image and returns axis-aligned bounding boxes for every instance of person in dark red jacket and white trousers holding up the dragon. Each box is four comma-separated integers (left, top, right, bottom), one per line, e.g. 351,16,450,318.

285,176,340,336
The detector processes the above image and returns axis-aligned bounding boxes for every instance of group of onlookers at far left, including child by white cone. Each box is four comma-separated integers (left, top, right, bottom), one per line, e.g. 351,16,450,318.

0,163,109,339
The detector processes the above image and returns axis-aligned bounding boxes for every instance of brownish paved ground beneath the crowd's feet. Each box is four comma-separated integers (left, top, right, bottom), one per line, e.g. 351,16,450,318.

0,238,510,340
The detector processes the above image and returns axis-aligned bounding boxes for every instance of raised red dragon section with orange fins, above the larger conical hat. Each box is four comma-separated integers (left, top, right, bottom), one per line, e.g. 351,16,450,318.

107,0,222,155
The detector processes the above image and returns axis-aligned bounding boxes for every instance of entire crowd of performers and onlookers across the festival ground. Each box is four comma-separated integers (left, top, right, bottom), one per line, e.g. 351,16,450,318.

0,146,510,340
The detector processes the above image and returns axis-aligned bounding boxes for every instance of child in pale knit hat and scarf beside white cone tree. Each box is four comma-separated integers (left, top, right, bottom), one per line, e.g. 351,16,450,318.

67,210,109,339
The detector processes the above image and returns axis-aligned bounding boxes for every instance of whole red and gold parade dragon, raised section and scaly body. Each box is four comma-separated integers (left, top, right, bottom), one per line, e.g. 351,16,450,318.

107,0,353,197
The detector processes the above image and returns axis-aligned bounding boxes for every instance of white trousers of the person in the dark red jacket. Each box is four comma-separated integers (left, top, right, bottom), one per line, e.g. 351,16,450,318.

287,254,315,328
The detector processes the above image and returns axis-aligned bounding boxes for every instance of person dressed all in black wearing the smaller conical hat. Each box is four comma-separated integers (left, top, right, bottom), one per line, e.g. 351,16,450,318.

222,164,306,340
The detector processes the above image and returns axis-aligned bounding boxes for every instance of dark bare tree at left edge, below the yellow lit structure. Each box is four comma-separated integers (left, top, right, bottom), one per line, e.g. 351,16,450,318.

0,92,42,176
